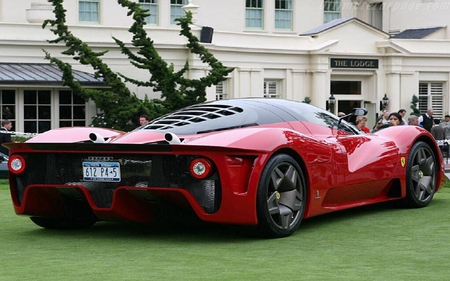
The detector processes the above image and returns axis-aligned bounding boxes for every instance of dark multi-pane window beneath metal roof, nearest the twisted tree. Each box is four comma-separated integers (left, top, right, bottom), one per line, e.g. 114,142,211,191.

59,90,86,127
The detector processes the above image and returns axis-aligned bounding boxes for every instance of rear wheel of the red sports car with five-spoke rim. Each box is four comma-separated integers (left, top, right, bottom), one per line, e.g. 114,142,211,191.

257,154,306,238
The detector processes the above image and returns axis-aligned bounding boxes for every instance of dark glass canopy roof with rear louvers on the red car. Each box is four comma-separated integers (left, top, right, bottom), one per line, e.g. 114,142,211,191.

141,98,362,135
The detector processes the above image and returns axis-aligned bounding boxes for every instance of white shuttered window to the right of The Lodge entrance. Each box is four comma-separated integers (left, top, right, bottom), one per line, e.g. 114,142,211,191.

419,82,444,118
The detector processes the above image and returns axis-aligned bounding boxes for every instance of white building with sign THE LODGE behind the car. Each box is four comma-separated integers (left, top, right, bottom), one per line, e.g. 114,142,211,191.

0,0,450,132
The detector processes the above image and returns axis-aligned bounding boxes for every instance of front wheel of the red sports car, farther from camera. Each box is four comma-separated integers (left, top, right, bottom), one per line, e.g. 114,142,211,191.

403,141,438,208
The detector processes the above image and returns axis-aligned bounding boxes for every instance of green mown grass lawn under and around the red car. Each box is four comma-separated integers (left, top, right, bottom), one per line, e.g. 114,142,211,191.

0,181,450,281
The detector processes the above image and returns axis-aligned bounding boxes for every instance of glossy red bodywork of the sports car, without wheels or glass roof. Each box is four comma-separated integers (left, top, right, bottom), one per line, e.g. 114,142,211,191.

7,99,445,229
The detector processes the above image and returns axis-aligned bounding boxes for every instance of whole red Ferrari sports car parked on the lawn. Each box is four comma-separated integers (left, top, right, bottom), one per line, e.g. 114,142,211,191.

6,98,445,237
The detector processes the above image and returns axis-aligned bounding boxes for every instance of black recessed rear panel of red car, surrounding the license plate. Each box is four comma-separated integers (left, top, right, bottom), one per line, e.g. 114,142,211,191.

15,153,221,213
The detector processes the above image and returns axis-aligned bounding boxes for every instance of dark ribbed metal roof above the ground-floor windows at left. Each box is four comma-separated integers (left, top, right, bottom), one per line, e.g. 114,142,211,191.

0,63,105,86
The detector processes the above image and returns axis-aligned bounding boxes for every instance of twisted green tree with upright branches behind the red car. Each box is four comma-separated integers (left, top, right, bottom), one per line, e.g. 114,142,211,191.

43,0,233,130
